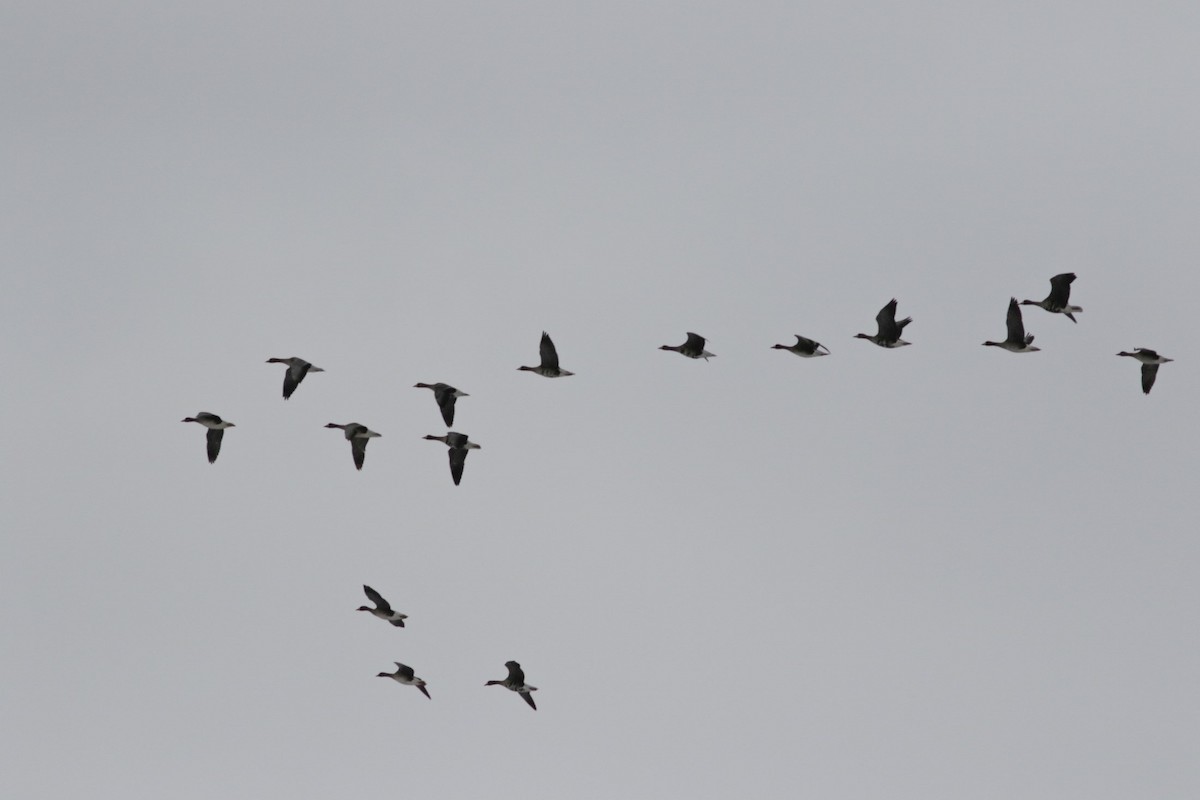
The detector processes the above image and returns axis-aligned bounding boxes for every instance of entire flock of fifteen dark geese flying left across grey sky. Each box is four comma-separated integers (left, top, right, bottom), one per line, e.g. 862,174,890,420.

182,272,1174,710
